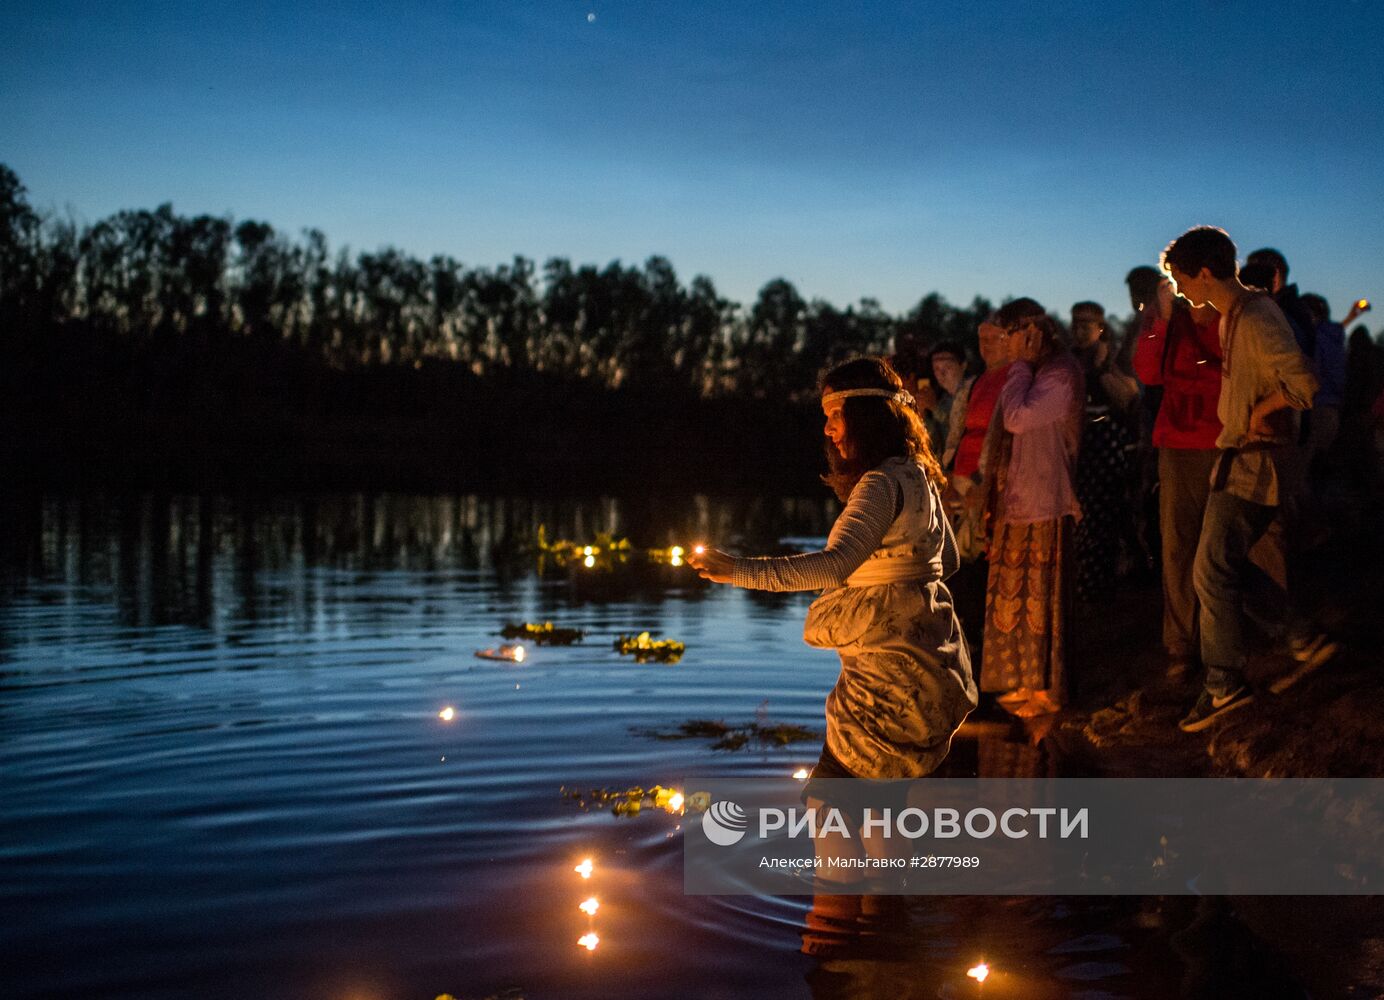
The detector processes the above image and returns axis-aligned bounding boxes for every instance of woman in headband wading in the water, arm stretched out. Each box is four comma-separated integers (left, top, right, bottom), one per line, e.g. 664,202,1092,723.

688,358,977,798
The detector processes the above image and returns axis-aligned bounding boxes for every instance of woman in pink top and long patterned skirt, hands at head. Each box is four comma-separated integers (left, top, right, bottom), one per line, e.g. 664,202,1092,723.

980,299,1085,718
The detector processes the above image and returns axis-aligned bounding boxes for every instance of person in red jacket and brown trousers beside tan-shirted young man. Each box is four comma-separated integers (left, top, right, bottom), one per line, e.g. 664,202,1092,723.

1133,278,1221,678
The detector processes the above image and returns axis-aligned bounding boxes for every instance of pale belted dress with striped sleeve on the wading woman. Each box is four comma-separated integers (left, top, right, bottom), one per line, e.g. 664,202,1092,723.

732,458,977,779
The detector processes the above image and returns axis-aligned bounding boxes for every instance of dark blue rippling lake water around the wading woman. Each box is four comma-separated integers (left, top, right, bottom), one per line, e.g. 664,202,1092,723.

0,495,1295,1000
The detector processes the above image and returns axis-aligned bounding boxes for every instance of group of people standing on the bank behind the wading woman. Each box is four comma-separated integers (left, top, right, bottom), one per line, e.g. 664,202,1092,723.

895,227,1367,732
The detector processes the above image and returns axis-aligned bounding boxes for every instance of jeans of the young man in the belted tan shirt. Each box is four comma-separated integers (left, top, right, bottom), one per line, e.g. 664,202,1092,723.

1192,490,1277,697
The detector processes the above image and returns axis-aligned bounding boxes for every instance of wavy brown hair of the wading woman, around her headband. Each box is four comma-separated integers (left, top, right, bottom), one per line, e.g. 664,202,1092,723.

821,357,947,503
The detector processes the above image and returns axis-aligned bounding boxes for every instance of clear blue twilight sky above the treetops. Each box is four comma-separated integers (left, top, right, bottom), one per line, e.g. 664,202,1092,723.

0,0,1384,329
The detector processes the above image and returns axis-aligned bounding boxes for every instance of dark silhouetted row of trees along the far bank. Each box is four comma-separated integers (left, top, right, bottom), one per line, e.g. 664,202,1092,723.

0,165,1018,492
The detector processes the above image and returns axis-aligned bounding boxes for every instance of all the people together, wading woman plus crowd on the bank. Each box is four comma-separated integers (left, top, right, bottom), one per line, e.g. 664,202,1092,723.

688,227,1367,801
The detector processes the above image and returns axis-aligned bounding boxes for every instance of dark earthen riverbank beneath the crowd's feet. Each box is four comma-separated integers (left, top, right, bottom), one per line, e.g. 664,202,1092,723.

1028,486,1384,999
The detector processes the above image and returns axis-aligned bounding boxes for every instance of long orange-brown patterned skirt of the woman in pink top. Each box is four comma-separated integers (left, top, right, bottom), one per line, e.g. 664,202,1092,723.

980,517,1073,701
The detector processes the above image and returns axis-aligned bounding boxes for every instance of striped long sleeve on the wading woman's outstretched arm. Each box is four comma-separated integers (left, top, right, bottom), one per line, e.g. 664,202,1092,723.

729,472,901,591
